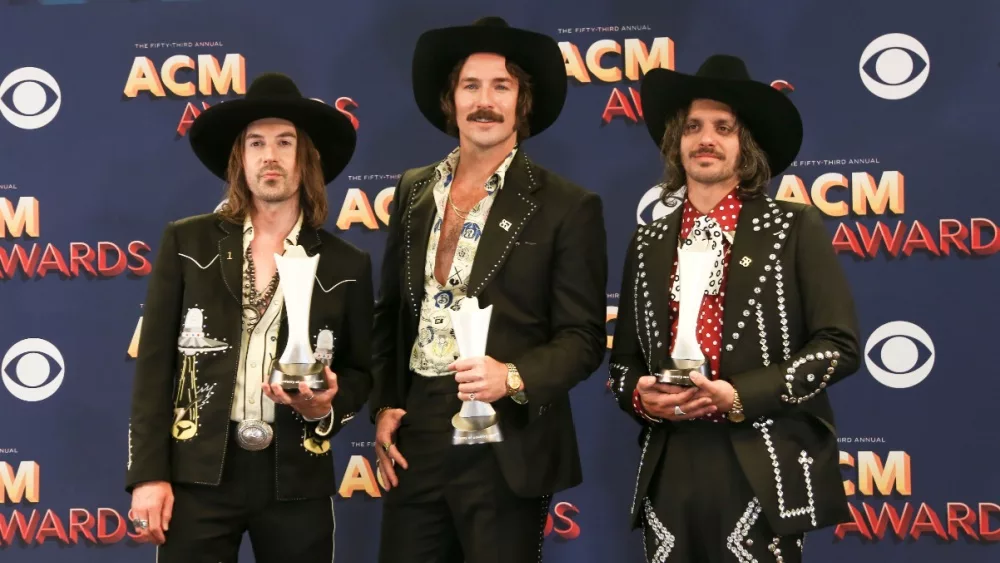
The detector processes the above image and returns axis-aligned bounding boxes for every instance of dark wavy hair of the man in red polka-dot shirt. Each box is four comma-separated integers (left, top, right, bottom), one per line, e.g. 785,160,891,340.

660,109,771,205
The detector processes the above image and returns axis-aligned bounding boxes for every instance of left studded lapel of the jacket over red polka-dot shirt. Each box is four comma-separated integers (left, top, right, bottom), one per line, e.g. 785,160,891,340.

633,207,683,371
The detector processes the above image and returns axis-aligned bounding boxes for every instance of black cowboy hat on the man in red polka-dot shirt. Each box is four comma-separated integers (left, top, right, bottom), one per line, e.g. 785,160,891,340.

640,55,802,177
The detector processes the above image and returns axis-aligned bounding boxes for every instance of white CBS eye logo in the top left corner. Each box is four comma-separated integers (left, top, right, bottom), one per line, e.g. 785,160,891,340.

0,67,62,129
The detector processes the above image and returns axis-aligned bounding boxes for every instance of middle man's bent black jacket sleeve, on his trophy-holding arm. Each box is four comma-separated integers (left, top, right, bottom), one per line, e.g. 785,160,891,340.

513,194,608,405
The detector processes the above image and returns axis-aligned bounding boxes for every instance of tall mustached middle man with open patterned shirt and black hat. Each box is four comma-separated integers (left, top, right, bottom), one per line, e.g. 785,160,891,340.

370,17,607,563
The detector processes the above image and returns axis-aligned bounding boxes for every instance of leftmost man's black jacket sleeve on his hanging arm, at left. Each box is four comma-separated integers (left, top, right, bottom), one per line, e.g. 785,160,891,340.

125,223,184,493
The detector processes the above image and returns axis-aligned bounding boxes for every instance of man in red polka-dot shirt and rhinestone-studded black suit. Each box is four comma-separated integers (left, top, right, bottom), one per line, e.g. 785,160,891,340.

610,55,859,563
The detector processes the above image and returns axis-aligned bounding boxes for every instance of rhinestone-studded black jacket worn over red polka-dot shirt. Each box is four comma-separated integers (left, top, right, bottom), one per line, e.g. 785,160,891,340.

611,197,859,535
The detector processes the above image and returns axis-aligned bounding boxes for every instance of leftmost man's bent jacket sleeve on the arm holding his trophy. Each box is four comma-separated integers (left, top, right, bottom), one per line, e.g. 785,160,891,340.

316,252,374,437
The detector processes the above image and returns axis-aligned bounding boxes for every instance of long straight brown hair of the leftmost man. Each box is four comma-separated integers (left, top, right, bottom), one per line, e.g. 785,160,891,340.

219,127,328,229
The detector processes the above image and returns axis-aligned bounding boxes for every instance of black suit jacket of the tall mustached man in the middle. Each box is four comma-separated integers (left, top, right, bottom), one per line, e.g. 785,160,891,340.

370,149,607,497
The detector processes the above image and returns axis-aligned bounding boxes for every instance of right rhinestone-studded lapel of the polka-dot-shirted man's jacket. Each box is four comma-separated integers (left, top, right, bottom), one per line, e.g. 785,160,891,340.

720,197,790,364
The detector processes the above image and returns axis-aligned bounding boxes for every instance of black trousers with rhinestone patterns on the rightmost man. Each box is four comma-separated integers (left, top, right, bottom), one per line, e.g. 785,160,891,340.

640,421,803,563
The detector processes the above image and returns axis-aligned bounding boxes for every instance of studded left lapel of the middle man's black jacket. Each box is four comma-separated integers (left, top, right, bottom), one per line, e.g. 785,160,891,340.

403,167,437,317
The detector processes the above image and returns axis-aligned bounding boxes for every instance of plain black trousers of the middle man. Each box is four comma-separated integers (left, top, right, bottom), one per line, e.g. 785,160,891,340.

379,375,551,563
